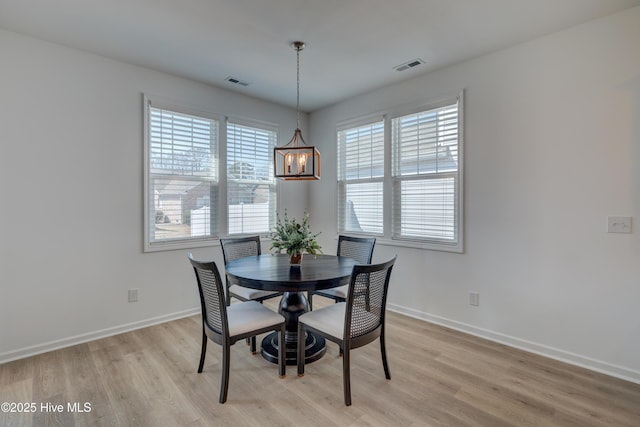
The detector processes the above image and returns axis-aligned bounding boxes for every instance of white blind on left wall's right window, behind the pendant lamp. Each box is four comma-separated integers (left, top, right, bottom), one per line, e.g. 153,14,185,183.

227,122,277,235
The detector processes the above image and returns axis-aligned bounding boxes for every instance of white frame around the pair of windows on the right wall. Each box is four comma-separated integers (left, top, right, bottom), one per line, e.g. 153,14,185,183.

335,90,465,253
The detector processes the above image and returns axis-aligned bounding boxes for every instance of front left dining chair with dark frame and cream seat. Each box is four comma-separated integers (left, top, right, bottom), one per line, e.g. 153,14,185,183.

189,254,286,403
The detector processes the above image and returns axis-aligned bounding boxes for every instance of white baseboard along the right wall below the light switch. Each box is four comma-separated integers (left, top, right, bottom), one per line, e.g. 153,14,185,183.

387,304,640,384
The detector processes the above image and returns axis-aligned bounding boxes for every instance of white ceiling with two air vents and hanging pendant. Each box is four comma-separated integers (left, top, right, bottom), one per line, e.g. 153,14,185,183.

0,0,640,112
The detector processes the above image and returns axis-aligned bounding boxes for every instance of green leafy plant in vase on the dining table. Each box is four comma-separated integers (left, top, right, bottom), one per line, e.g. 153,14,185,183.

271,210,322,265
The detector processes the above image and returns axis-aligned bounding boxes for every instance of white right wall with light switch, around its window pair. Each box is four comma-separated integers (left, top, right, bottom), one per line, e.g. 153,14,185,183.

309,8,640,382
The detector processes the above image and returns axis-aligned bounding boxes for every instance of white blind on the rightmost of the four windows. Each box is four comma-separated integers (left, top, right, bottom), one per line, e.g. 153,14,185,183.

392,101,461,246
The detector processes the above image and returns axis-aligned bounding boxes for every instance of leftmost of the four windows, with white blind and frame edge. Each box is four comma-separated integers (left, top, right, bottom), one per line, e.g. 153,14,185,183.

145,98,219,251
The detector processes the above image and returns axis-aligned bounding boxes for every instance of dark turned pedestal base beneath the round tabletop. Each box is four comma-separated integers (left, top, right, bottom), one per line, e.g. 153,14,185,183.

262,292,327,365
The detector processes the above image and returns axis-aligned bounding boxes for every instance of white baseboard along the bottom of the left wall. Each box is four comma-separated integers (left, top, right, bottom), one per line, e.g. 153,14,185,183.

0,307,200,364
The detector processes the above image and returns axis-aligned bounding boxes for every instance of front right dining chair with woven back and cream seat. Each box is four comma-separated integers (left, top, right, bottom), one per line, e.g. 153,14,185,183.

298,255,397,406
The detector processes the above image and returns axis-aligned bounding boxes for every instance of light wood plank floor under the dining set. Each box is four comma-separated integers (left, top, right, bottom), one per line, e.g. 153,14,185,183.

0,298,640,427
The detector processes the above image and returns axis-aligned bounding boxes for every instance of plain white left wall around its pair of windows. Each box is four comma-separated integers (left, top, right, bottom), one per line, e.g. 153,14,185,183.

0,30,306,363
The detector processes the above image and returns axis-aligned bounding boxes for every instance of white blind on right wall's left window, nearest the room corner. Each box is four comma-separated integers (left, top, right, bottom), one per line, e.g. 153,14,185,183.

337,120,385,235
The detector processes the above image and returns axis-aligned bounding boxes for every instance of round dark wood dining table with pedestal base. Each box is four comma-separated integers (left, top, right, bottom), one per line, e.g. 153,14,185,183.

225,254,357,365
